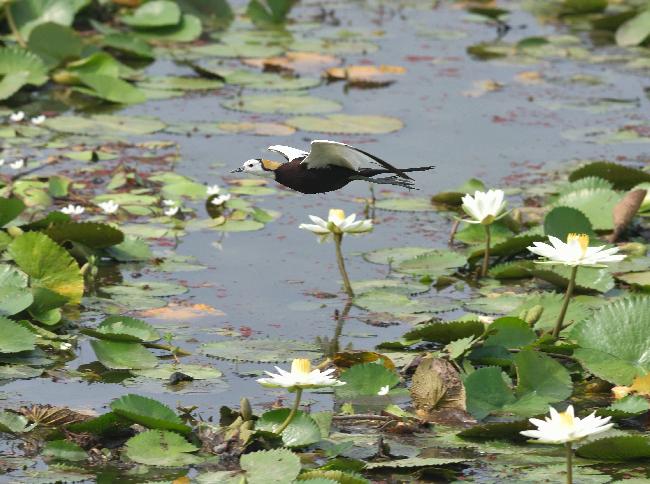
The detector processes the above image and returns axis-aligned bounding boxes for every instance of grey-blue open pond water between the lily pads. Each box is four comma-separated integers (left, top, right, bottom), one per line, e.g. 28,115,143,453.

0,1,648,482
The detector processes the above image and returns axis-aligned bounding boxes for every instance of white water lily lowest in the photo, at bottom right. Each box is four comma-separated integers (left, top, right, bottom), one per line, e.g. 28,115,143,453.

521,405,614,444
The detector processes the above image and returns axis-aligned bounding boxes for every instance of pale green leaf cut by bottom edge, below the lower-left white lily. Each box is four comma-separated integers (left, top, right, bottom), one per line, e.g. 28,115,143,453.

239,449,301,484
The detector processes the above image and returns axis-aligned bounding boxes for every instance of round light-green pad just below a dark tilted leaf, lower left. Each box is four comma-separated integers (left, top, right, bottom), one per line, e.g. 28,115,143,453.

126,430,199,467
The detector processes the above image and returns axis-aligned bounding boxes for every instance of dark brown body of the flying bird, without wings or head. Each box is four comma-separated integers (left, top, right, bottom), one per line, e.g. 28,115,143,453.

274,159,359,194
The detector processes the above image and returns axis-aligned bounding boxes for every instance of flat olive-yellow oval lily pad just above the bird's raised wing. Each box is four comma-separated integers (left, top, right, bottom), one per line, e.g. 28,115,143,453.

285,114,404,134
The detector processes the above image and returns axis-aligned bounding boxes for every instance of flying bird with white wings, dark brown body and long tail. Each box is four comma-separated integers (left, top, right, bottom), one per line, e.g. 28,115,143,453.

231,140,433,194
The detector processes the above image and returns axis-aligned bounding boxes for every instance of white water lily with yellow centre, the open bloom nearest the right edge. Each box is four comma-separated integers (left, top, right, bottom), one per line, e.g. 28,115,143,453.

528,234,625,267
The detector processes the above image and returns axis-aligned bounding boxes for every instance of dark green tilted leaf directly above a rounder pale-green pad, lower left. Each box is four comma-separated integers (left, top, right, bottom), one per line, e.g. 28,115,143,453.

111,394,191,434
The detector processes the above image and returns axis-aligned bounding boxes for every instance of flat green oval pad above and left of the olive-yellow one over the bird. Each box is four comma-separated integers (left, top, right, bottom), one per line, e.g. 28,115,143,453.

222,94,341,114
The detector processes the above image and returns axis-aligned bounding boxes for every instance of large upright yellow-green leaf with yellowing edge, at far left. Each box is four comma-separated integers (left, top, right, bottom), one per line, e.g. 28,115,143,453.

9,232,84,303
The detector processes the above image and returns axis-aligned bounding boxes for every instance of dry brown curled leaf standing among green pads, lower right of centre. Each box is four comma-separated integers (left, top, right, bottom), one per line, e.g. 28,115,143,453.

410,355,466,421
